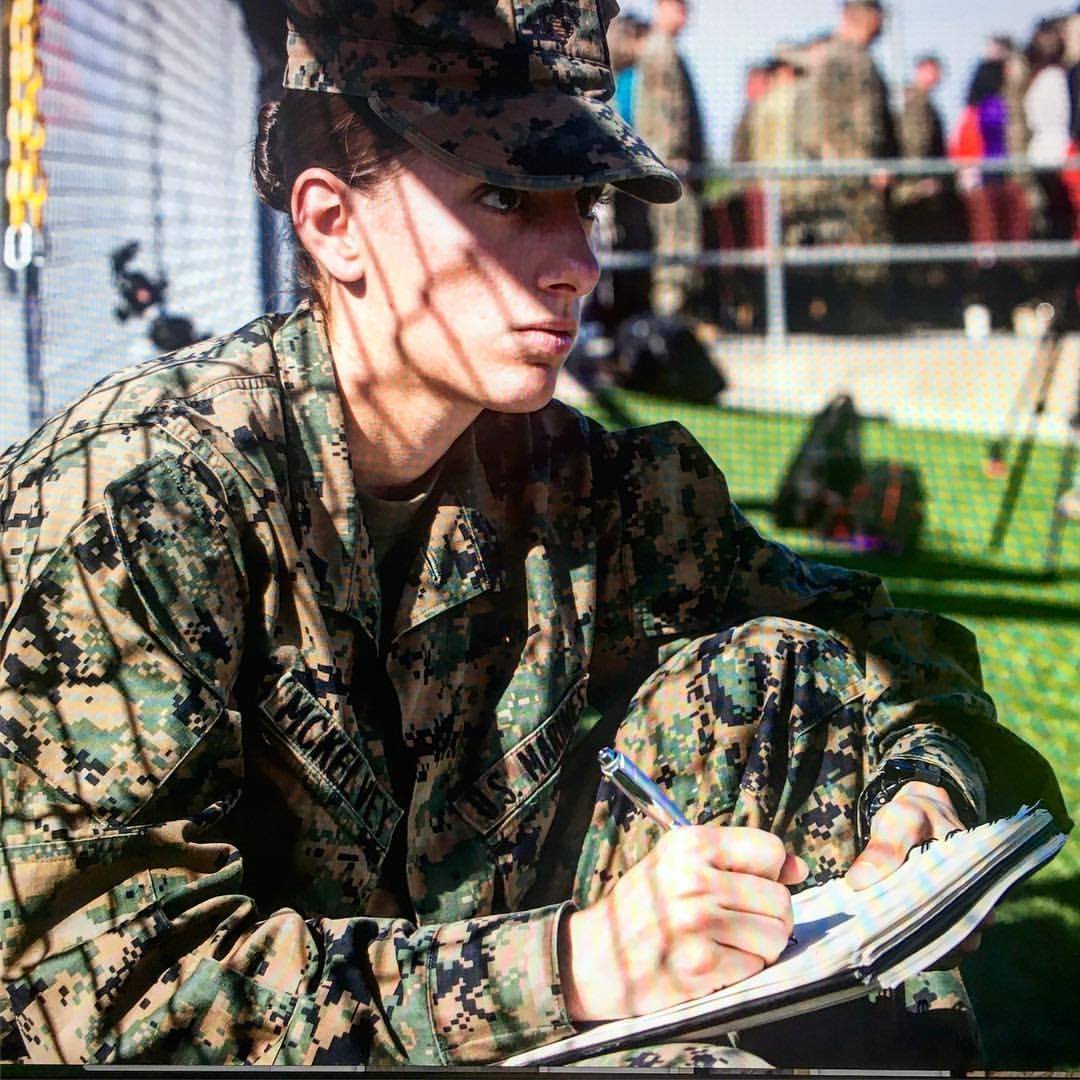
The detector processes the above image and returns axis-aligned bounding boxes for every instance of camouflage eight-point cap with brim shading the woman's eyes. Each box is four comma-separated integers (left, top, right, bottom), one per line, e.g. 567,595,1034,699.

285,0,681,203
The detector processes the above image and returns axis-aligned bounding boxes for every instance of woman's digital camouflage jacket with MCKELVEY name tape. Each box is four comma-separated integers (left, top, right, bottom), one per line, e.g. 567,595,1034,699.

0,306,1062,1065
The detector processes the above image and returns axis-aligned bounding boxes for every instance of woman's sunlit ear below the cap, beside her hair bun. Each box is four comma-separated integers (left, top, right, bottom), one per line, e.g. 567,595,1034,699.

292,168,366,282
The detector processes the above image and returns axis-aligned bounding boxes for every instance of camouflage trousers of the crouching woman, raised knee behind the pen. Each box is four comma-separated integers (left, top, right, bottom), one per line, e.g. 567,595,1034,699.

540,619,978,1069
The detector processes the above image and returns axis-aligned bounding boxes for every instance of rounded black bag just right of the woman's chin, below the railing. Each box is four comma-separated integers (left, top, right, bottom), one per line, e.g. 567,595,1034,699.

616,315,728,404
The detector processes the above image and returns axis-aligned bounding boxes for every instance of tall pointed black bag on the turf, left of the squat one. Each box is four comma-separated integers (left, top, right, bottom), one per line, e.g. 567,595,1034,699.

772,394,864,537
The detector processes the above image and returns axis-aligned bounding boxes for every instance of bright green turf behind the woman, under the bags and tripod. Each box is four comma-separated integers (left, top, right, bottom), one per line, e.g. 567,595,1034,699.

588,391,1080,1069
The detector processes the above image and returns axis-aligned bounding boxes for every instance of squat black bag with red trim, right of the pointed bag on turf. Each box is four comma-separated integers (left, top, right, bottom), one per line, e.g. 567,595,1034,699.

850,461,926,555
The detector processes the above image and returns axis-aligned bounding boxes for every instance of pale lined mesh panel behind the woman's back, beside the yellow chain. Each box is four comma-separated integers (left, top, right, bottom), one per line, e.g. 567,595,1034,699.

0,0,264,445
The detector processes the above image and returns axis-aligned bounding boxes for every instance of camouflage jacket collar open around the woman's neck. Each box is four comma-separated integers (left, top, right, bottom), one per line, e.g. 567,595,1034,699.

273,301,501,642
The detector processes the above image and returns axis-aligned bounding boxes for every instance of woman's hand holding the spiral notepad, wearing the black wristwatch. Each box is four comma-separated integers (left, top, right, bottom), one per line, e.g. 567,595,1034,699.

846,780,994,970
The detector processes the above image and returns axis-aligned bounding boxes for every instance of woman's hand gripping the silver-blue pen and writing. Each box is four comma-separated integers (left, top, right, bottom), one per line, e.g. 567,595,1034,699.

559,825,807,1021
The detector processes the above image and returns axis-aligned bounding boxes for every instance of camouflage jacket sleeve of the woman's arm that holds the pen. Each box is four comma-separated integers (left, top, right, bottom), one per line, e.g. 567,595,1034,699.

0,444,572,1065
